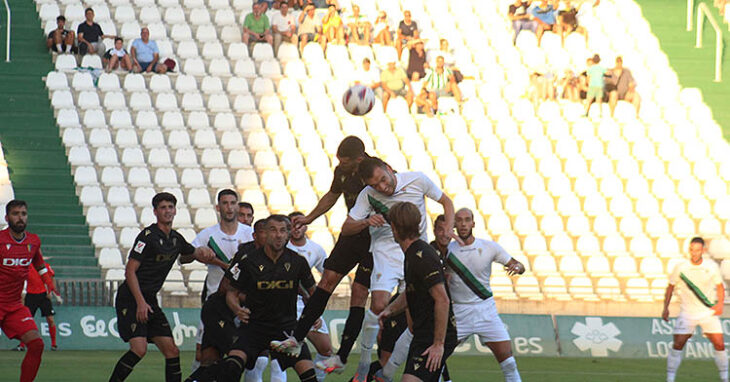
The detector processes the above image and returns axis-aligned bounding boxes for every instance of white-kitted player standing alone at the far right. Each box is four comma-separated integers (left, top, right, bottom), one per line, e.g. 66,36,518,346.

662,237,728,382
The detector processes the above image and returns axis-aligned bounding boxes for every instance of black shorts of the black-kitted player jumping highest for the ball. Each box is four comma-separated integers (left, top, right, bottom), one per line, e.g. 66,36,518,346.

324,230,373,288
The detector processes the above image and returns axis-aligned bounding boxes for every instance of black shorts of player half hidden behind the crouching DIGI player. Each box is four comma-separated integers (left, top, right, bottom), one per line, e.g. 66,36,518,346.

200,294,238,354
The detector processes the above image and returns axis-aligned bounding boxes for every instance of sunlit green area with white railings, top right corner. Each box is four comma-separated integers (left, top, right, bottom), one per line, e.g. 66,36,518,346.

637,0,730,139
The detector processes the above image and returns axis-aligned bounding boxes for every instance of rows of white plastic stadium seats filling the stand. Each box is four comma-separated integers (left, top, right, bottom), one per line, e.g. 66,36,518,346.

29,0,730,301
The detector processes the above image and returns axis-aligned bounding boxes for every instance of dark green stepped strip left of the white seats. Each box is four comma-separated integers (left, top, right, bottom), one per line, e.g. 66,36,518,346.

0,0,100,278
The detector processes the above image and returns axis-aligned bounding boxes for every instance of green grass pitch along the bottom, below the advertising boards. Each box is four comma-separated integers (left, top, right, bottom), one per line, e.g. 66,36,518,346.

0,351,718,382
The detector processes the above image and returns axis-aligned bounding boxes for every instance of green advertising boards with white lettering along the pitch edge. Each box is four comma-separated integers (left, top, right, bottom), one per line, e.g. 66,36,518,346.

0,306,730,358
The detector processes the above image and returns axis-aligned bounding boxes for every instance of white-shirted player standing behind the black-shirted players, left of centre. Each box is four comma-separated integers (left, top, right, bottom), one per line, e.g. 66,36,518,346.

193,189,253,371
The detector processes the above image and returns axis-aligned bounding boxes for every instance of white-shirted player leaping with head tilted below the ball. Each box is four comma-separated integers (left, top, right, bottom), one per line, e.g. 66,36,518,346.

342,157,458,376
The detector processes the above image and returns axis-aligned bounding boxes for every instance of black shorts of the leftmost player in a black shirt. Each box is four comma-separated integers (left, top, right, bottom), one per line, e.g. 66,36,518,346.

114,284,172,342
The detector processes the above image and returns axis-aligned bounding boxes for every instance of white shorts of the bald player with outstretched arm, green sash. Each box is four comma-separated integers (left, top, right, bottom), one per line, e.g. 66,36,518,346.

452,298,510,343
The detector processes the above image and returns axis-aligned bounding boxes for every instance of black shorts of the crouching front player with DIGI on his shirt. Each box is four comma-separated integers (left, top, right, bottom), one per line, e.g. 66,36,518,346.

231,324,312,370
